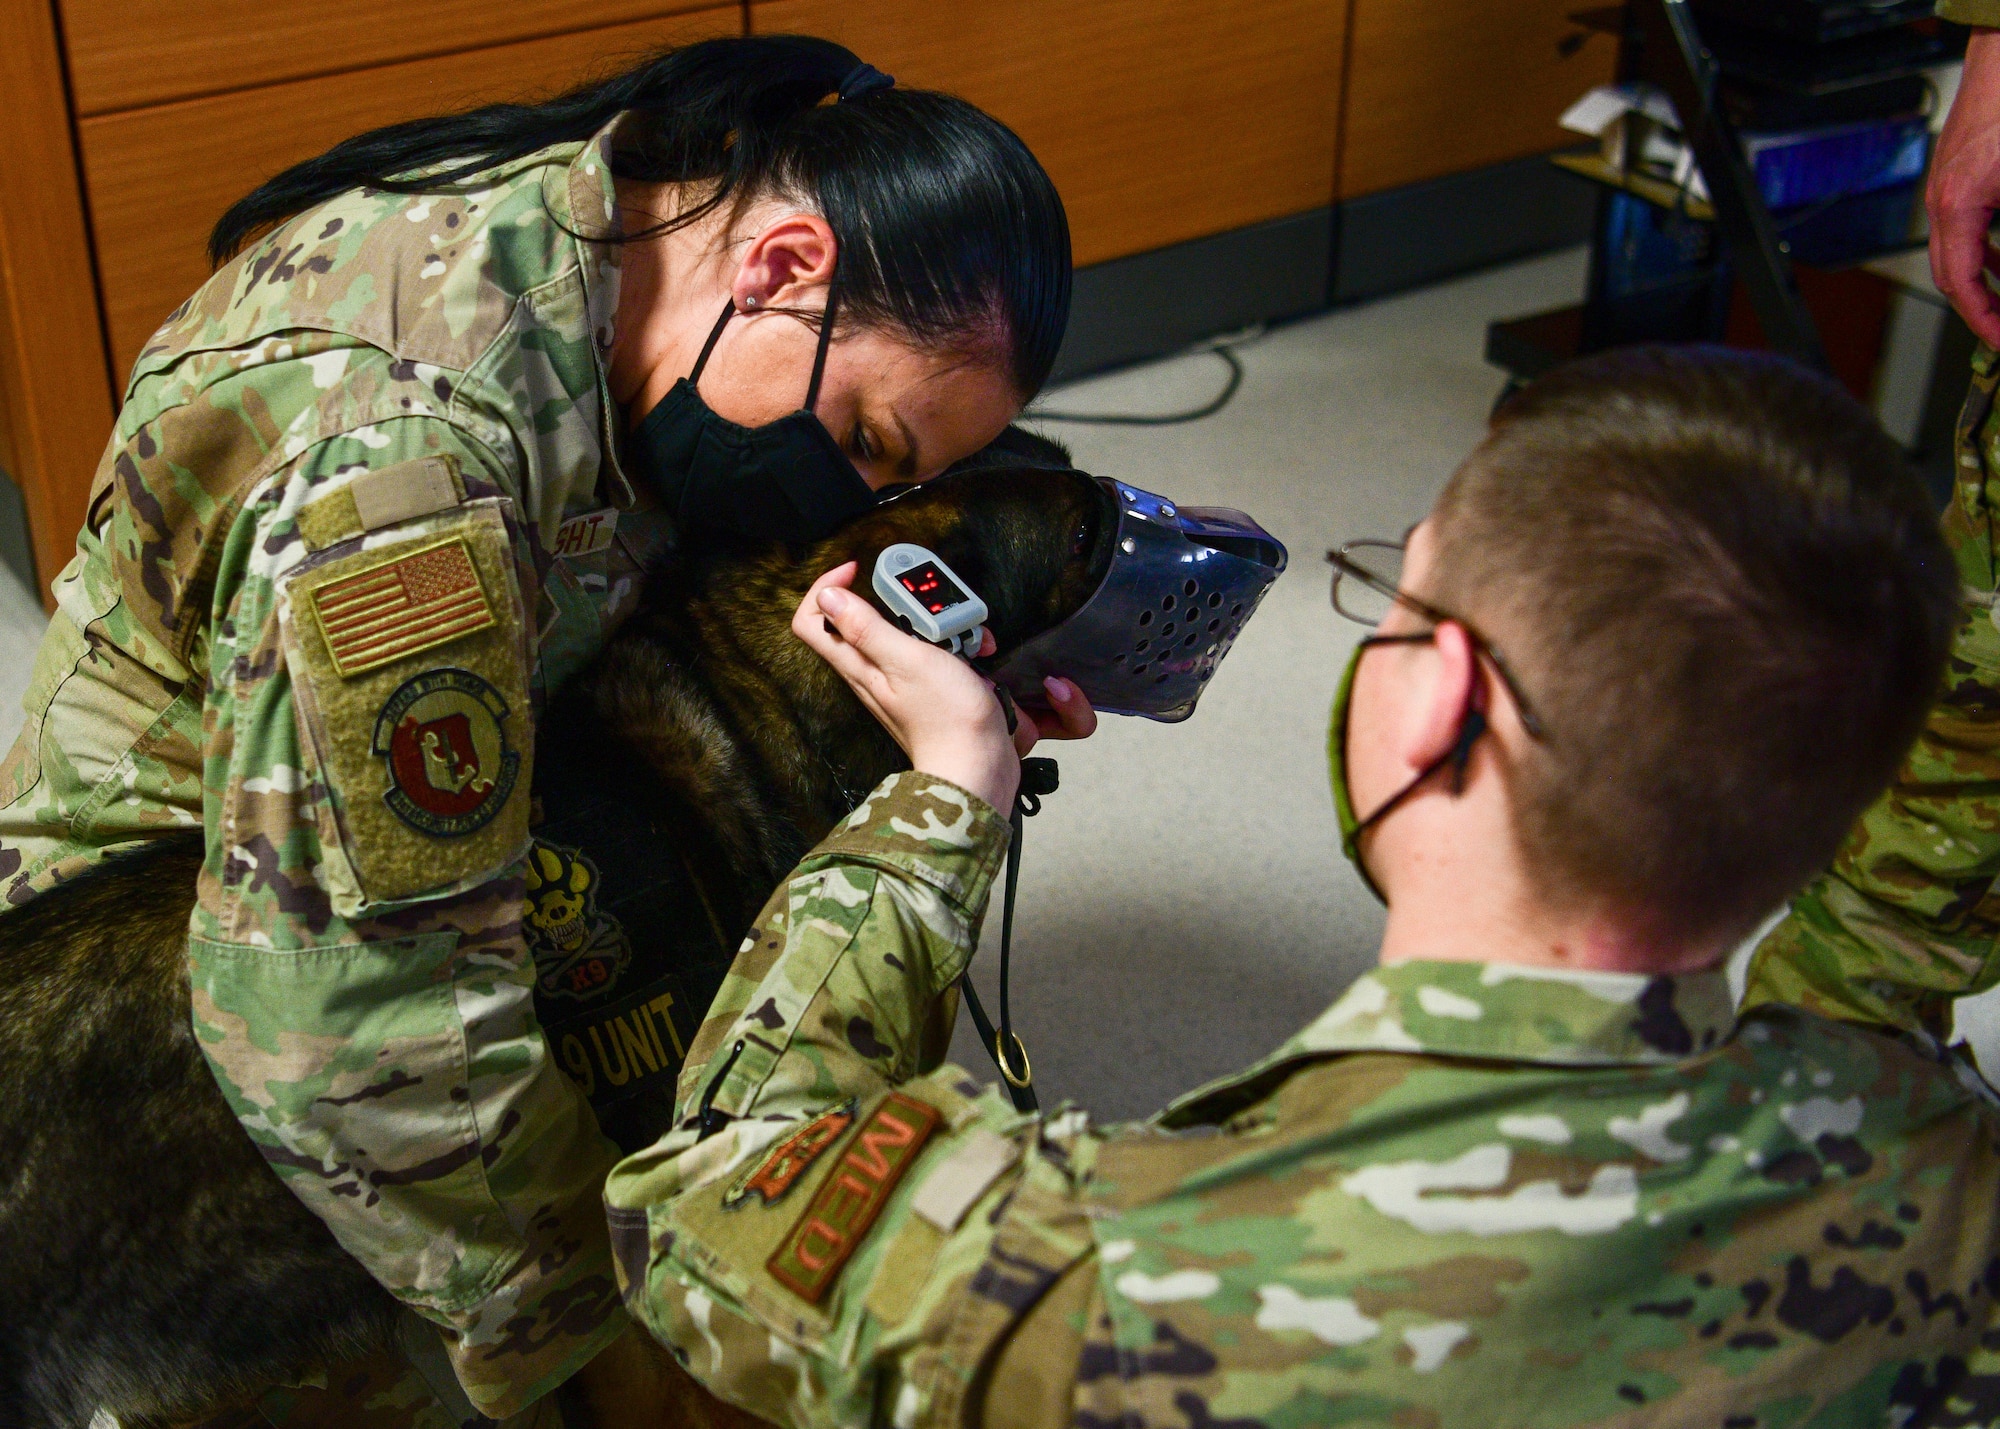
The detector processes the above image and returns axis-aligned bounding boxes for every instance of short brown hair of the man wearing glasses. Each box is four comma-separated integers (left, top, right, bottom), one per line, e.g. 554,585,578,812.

1414,348,1960,937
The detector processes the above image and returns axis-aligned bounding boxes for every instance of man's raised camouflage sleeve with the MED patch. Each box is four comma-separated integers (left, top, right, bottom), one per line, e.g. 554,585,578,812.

606,773,1092,1425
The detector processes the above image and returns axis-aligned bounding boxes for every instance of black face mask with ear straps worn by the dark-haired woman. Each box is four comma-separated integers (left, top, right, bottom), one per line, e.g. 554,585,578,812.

628,292,876,544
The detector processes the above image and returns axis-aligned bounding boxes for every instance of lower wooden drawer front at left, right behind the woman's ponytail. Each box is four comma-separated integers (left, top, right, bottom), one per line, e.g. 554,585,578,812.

78,4,742,384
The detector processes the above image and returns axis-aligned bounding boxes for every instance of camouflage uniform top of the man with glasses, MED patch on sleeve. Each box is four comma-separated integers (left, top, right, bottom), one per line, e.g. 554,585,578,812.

606,775,2000,1429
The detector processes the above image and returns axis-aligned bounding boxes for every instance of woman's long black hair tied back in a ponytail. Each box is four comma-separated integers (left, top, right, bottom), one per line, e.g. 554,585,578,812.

208,34,1070,398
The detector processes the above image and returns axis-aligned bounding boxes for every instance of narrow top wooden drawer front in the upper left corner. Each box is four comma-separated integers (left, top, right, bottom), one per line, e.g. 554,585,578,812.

62,0,744,114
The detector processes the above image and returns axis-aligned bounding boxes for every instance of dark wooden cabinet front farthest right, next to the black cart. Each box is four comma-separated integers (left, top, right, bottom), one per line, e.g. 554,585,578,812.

1340,0,1618,198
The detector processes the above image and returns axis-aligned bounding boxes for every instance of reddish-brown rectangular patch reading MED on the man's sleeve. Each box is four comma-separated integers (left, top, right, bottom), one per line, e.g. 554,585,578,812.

766,1093,940,1305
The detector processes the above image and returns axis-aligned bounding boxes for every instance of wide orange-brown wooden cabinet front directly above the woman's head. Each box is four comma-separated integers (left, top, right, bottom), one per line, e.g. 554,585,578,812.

750,0,1346,264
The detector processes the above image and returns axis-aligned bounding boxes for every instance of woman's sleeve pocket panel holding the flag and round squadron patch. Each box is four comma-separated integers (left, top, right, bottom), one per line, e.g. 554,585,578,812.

278,502,532,917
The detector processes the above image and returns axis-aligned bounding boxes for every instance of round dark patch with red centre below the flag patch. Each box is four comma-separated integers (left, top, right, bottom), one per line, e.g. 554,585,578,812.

372,668,520,839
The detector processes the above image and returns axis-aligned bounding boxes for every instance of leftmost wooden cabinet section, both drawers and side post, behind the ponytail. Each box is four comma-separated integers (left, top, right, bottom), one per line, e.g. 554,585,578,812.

0,0,744,598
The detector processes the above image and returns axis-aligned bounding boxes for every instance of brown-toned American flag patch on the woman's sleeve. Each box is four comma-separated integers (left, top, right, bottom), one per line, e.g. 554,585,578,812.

312,536,496,678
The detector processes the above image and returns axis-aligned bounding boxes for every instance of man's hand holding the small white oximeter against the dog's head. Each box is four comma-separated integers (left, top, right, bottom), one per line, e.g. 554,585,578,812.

792,560,1098,813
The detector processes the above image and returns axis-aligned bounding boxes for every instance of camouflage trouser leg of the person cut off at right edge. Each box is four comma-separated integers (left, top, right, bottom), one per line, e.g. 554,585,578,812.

1744,348,2000,1037
